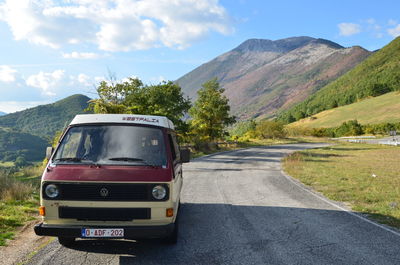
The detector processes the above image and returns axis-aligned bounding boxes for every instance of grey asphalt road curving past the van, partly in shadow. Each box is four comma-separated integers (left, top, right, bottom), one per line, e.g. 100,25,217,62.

25,144,400,265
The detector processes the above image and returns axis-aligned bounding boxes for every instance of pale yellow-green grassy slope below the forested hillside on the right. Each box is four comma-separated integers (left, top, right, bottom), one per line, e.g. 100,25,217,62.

291,91,400,128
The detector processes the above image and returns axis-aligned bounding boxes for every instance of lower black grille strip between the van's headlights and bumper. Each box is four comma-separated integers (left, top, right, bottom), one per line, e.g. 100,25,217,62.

58,206,151,221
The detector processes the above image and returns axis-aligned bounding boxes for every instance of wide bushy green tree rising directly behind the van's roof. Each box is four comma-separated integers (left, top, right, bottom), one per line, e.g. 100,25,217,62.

89,78,191,135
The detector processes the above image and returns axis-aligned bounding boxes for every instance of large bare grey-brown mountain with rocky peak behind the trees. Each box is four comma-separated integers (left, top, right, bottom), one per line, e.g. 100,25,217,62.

176,37,370,119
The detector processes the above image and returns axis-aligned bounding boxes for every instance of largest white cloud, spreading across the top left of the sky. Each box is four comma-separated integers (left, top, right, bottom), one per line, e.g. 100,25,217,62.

0,0,233,51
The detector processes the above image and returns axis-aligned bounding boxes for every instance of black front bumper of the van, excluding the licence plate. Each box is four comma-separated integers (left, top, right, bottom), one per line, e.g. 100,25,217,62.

34,223,175,239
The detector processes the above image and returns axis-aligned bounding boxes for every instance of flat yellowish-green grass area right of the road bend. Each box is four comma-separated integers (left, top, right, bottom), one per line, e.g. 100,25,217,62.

283,144,400,228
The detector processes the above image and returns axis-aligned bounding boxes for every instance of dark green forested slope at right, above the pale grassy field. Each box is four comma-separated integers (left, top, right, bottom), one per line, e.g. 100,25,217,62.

280,37,400,122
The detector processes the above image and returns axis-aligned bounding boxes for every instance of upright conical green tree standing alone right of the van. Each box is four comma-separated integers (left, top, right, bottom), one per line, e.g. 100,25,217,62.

189,78,235,141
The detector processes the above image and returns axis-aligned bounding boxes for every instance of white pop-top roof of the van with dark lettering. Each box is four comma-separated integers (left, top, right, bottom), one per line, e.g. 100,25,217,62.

70,114,174,129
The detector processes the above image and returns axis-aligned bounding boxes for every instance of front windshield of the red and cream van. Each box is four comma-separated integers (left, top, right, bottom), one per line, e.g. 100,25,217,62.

52,125,167,166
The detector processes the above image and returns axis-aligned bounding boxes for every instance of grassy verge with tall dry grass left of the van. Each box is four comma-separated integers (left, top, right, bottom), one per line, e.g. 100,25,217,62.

0,167,41,246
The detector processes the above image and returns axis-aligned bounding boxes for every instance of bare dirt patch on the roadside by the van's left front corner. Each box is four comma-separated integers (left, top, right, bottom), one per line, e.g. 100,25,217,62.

0,220,52,265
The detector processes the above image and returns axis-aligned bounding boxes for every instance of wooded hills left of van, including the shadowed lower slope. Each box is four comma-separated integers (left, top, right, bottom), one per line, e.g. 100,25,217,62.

0,95,90,161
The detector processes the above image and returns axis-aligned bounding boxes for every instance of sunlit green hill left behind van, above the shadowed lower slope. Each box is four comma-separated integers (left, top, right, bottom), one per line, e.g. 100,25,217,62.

0,95,90,138
